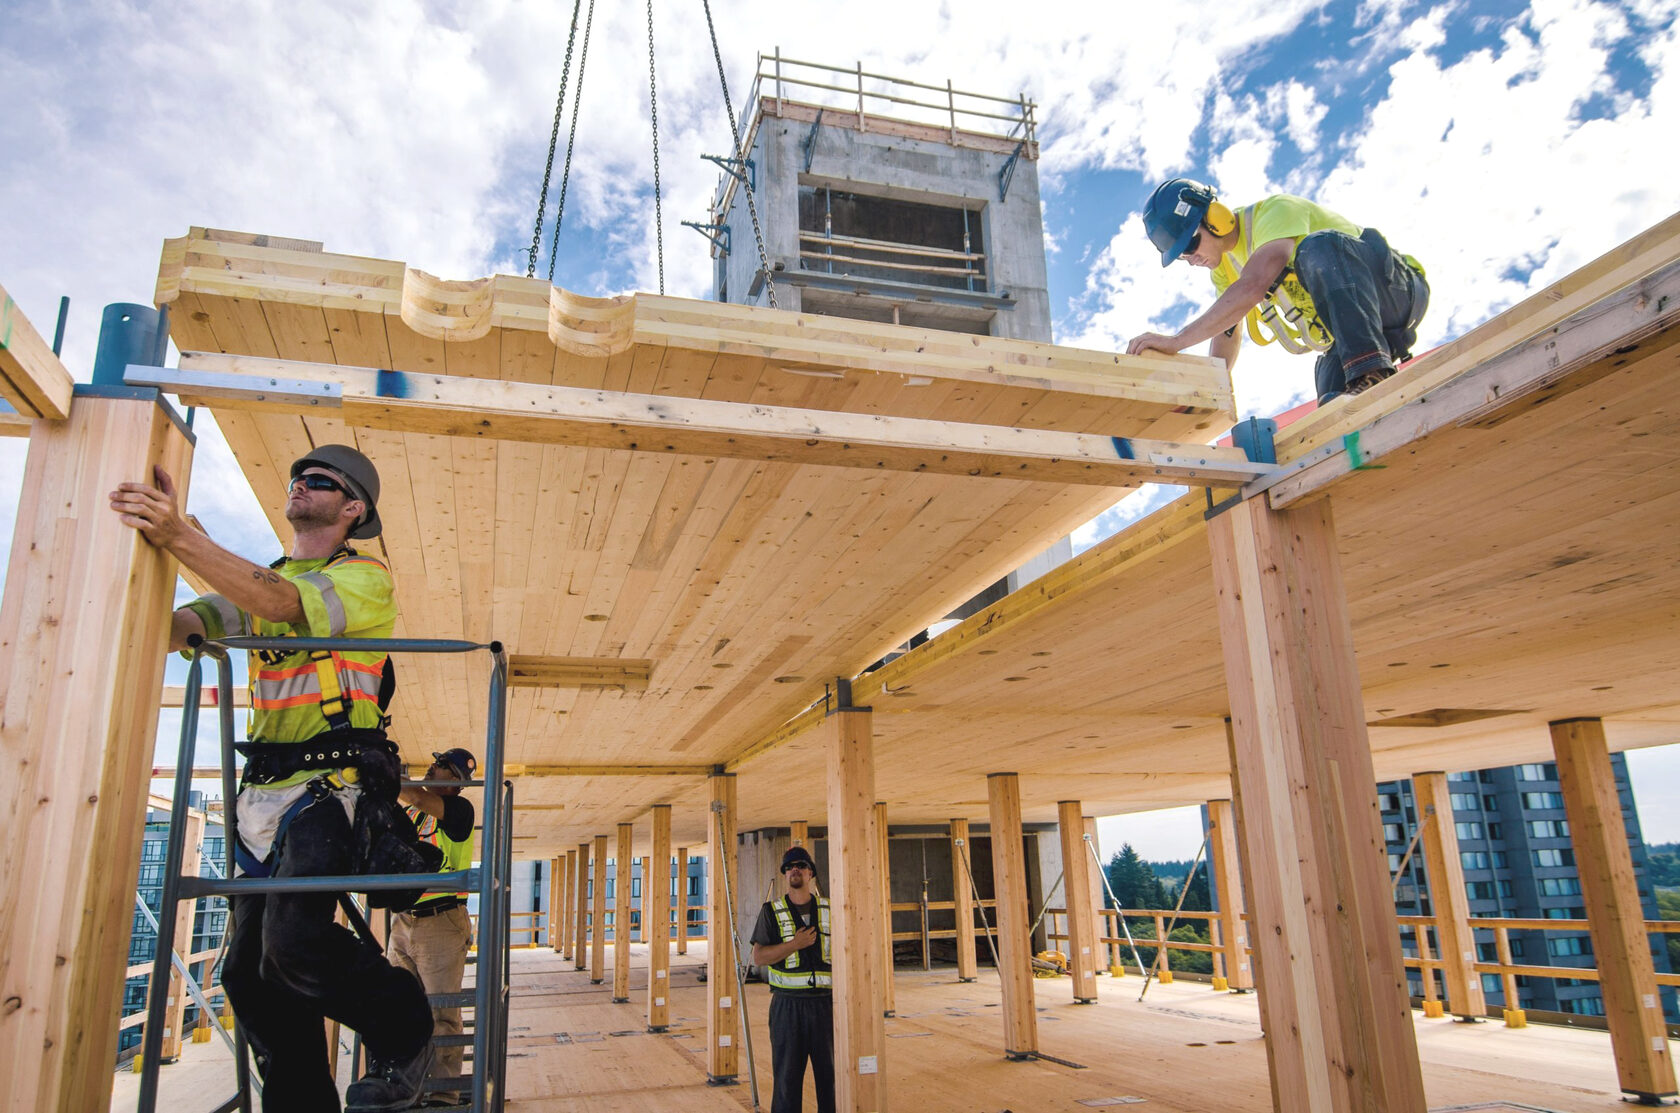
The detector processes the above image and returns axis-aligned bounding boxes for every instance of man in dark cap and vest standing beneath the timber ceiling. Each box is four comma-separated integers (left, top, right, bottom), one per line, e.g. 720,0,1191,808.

753,846,835,1113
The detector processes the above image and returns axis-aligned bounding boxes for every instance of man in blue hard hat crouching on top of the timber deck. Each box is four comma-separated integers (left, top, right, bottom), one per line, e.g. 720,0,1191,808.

1126,178,1430,405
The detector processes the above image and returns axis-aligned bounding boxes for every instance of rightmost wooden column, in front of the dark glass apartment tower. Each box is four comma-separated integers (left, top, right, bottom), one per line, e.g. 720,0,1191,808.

1551,720,1675,1105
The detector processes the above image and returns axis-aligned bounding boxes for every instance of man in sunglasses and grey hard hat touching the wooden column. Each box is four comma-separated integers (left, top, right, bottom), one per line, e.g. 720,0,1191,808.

111,444,432,1113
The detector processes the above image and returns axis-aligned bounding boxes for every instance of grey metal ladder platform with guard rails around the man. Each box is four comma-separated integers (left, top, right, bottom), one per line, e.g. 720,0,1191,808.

138,637,512,1113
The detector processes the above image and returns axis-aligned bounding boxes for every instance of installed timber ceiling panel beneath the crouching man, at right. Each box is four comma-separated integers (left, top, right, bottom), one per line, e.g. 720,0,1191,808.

715,218,1680,840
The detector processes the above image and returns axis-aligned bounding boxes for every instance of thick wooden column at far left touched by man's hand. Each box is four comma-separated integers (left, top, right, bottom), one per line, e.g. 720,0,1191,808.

0,391,193,1113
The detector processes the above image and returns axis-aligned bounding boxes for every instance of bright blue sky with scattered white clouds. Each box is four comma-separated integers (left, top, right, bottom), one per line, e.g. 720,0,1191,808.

0,0,1680,857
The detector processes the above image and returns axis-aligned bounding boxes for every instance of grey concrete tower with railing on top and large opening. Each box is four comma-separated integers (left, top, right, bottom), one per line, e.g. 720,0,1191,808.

698,52,1050,341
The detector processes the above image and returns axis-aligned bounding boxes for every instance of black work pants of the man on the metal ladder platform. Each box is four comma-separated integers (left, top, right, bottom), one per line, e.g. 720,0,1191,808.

222,797,432,1113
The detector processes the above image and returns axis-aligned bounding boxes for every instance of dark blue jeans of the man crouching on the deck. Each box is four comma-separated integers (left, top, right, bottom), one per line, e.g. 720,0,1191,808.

1295,229,1430,402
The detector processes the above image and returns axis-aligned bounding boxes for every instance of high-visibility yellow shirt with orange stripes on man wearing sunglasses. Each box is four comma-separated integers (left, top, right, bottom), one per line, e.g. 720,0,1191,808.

186,548,396,789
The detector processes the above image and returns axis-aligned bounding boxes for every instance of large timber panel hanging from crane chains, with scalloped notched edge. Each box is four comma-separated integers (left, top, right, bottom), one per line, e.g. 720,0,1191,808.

158,230,1231,856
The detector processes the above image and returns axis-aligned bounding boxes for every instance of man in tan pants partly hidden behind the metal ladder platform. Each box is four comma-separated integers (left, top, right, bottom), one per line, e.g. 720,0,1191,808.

385,746,479,1106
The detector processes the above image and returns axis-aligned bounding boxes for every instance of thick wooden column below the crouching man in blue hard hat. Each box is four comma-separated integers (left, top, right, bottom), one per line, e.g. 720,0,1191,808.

1208,498,1426,1113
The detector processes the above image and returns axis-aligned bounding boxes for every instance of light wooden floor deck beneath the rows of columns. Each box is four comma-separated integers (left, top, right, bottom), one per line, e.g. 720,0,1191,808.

111,945,1653,1113
